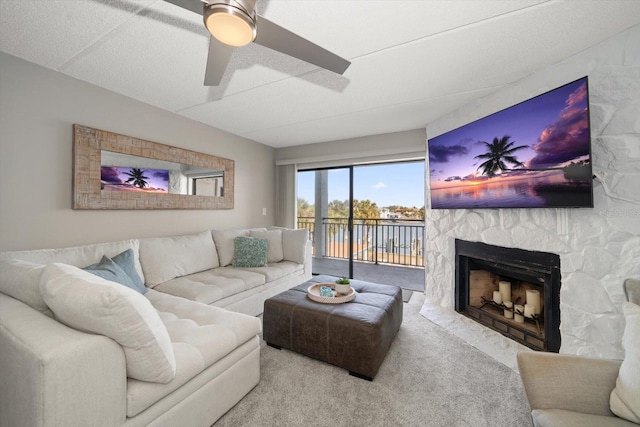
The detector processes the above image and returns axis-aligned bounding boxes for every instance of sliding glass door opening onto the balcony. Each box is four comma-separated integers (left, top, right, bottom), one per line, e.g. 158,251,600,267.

297,161,425,290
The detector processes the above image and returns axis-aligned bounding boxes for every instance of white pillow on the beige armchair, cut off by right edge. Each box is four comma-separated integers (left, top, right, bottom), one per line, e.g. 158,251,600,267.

609,302,640,424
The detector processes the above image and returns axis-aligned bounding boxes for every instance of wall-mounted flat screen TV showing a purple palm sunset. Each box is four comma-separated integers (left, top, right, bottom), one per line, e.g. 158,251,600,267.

428,77,593,209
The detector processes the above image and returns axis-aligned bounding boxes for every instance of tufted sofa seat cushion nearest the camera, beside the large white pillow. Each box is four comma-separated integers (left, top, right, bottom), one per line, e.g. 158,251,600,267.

127,290,262,417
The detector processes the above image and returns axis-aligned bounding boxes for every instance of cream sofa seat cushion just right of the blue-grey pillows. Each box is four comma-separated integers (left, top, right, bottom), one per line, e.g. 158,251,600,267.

154,267,265,304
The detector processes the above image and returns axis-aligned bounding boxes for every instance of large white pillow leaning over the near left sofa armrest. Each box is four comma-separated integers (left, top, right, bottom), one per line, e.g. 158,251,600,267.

40,263,176,383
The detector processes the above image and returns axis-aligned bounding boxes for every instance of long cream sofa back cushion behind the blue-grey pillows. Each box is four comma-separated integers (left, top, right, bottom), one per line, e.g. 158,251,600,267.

0,239,144,283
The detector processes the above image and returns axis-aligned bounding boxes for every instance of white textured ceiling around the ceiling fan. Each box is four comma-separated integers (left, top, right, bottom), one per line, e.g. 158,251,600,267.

0,0,640,147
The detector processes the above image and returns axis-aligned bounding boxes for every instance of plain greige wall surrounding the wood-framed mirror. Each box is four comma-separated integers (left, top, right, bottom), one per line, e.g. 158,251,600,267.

0,53,275,251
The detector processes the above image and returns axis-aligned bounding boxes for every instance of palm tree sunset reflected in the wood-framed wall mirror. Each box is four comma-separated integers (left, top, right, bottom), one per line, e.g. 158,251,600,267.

100,166,169,194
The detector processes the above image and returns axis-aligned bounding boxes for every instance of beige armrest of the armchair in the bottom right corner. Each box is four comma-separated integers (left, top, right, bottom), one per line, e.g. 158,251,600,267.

518,352,622,416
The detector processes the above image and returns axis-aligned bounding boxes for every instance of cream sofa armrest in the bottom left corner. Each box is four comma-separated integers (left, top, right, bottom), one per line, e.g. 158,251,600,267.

0,293,127,427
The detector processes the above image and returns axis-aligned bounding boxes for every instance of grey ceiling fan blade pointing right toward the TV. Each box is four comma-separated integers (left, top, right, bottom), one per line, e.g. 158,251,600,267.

254,15,351,74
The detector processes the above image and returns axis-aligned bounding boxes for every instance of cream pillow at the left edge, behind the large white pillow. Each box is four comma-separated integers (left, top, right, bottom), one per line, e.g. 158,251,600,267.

0,259,53,317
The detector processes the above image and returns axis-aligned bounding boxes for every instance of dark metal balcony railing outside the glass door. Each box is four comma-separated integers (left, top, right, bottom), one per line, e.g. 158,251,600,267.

298,217,424,267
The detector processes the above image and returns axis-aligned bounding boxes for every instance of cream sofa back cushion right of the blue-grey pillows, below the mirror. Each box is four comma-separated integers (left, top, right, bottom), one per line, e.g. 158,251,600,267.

140,231,220,288
